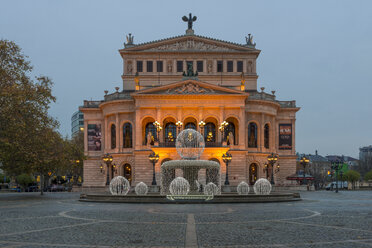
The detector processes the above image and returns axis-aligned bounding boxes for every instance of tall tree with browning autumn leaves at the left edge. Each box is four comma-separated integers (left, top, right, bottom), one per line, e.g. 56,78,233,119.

0,40,58,175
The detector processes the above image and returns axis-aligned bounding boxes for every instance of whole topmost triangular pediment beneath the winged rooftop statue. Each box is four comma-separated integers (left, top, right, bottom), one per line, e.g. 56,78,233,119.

121,35,259,52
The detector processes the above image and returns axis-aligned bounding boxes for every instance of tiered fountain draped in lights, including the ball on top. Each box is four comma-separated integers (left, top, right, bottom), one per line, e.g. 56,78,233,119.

160,129,221,195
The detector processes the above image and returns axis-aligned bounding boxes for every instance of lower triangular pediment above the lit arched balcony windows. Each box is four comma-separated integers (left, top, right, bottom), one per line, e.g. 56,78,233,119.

134,80,246,96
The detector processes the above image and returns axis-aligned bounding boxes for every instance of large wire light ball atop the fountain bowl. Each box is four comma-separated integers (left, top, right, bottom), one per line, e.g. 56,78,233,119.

176,129,205,160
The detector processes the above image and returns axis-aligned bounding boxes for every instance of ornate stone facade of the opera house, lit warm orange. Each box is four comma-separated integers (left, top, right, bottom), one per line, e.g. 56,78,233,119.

80,27,299,190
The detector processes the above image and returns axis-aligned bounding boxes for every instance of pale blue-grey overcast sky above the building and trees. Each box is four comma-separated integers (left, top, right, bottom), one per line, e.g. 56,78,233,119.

0,0,372,157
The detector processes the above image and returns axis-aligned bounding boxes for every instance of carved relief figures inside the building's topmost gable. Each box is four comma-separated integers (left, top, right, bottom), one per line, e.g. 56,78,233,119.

147,39,235,52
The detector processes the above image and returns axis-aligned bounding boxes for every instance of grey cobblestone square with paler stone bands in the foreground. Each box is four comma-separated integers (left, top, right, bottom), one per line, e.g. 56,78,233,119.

0,191,372,248
